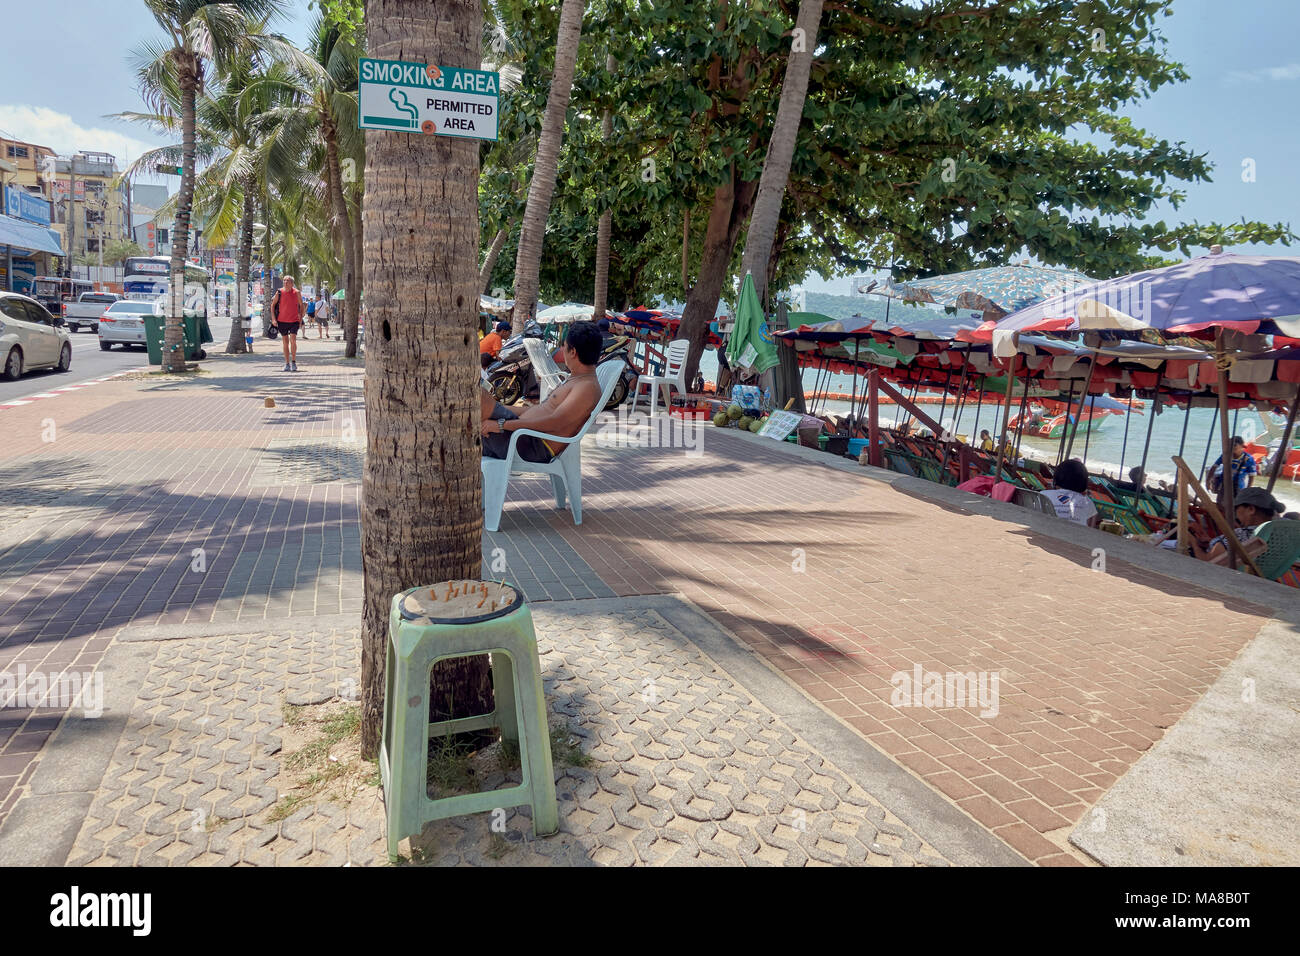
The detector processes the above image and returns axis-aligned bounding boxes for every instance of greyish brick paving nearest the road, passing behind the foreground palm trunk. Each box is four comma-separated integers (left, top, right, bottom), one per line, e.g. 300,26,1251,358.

0,341,614,822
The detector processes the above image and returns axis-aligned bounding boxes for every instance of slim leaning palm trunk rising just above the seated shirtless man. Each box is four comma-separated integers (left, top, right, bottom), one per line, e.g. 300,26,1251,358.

515,0,586,333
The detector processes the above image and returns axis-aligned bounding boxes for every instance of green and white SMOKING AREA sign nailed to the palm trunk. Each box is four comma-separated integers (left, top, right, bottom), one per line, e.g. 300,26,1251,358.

358,59,501,139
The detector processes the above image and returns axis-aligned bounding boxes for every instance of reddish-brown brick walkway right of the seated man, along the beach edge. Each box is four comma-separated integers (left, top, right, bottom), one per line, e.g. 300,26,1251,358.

537,433,1268,864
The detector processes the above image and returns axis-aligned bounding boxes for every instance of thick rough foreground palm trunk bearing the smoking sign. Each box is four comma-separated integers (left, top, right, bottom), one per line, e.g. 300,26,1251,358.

361,0,491,756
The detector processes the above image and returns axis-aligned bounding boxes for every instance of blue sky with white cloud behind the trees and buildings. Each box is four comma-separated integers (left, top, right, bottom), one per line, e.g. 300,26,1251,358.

0,0,1300,293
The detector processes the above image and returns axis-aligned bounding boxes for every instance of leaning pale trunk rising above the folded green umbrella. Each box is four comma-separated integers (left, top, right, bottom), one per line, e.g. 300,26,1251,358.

740,0,822,302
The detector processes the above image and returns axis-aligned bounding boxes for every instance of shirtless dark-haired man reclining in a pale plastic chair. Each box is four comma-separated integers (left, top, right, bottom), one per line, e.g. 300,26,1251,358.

480,323,603,462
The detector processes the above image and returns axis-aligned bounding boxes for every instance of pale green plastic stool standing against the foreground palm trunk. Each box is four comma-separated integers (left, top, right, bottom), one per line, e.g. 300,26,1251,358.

380,580,559,862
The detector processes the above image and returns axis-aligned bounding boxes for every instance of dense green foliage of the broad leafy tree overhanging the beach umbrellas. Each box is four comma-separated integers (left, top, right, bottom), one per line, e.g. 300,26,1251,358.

485,0,1291,385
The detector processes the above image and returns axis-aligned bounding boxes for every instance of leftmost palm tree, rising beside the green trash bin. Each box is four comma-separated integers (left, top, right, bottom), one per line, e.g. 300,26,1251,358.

137,0,282,372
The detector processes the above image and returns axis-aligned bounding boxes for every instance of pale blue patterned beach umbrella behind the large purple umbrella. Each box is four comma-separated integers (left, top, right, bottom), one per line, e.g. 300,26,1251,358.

875,263,1093,315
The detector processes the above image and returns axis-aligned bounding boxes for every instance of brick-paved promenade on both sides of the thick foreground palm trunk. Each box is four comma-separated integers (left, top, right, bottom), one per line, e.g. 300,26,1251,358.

0,343,1269,864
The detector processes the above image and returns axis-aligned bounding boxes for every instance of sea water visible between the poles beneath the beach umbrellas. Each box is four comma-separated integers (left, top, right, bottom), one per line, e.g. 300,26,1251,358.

699,351,1300,510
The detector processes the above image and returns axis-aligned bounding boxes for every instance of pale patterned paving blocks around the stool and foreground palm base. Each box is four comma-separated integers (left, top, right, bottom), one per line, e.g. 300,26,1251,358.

68,604,946,866
